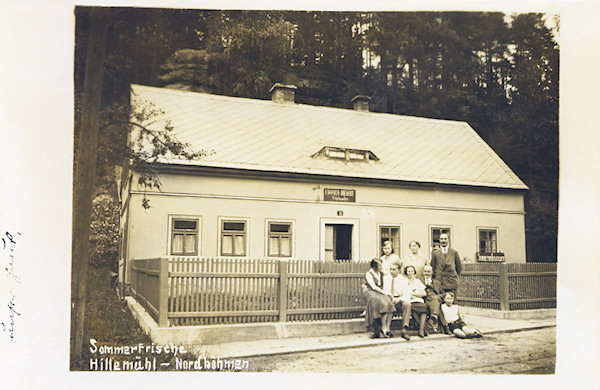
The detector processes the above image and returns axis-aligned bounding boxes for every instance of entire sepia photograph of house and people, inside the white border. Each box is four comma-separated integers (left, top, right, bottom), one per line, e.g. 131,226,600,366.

71,6,560,374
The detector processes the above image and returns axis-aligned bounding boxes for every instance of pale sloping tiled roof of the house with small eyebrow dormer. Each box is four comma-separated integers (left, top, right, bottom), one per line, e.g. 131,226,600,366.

132,85,527,189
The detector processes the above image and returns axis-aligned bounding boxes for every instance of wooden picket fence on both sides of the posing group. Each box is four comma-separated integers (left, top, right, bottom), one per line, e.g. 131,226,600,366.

131,257,556,326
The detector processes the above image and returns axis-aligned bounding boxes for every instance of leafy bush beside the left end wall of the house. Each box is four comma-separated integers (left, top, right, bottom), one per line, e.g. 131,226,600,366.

89,196,120,270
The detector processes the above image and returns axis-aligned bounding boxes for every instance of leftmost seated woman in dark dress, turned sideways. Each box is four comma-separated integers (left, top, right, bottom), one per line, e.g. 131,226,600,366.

364,258,396,338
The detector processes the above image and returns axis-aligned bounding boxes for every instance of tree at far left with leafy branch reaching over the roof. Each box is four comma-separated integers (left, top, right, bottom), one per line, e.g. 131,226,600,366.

70,7,210,369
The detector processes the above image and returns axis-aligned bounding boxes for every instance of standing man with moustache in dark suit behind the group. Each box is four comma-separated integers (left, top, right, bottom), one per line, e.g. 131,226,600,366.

431,233,462,296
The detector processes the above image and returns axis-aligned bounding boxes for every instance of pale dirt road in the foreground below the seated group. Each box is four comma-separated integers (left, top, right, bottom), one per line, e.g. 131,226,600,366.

250,327,556,374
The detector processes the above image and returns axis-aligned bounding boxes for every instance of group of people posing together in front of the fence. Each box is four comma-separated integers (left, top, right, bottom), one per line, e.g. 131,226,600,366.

363,233,481,340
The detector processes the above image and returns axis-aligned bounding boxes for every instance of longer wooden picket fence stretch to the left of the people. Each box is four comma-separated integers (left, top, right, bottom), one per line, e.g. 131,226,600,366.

131,257,369,326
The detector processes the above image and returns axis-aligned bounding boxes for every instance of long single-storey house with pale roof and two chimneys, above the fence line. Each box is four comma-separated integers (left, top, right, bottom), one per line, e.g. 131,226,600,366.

121,84,527,280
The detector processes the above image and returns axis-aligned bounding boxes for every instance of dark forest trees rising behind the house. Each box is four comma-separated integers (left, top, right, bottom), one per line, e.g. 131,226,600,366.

76,8,559,261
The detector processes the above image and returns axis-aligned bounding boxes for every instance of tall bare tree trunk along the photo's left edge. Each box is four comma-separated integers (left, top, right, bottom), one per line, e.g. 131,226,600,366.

71,7,108,369
